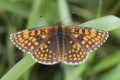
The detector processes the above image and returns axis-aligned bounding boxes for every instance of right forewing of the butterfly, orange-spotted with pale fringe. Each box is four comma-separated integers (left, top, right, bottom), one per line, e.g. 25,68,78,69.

65,26,109,52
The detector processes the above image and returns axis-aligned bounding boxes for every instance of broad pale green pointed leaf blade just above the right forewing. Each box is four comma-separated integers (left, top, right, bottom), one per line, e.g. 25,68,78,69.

80,16,120,31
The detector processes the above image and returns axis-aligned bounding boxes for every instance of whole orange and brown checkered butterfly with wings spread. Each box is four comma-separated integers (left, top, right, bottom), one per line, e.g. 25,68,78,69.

10,21,109,65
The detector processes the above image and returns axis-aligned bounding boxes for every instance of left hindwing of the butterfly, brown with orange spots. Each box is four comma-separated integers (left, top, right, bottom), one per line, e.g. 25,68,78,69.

32,35,59,65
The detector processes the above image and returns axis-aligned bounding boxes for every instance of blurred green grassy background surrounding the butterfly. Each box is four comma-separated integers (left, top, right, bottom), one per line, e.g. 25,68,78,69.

0,0,120,80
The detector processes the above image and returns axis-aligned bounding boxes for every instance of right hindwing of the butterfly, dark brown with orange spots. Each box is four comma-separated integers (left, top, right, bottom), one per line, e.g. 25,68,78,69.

63,35,87,65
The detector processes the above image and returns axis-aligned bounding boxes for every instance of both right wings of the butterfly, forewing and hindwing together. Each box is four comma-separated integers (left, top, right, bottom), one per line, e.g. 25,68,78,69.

64,26,109,64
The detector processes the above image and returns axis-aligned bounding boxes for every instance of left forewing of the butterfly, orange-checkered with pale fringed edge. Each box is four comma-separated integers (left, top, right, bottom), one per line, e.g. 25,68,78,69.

10,27,54,53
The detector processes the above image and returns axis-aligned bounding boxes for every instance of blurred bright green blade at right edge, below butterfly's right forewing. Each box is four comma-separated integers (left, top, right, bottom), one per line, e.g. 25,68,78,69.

92,51,120,74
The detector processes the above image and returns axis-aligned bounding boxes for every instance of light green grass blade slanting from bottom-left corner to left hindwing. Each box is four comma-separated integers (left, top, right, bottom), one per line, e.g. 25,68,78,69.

1,55,35,80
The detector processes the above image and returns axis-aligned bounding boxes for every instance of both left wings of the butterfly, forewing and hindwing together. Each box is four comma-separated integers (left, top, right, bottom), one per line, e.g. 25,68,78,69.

10,27,57,64
